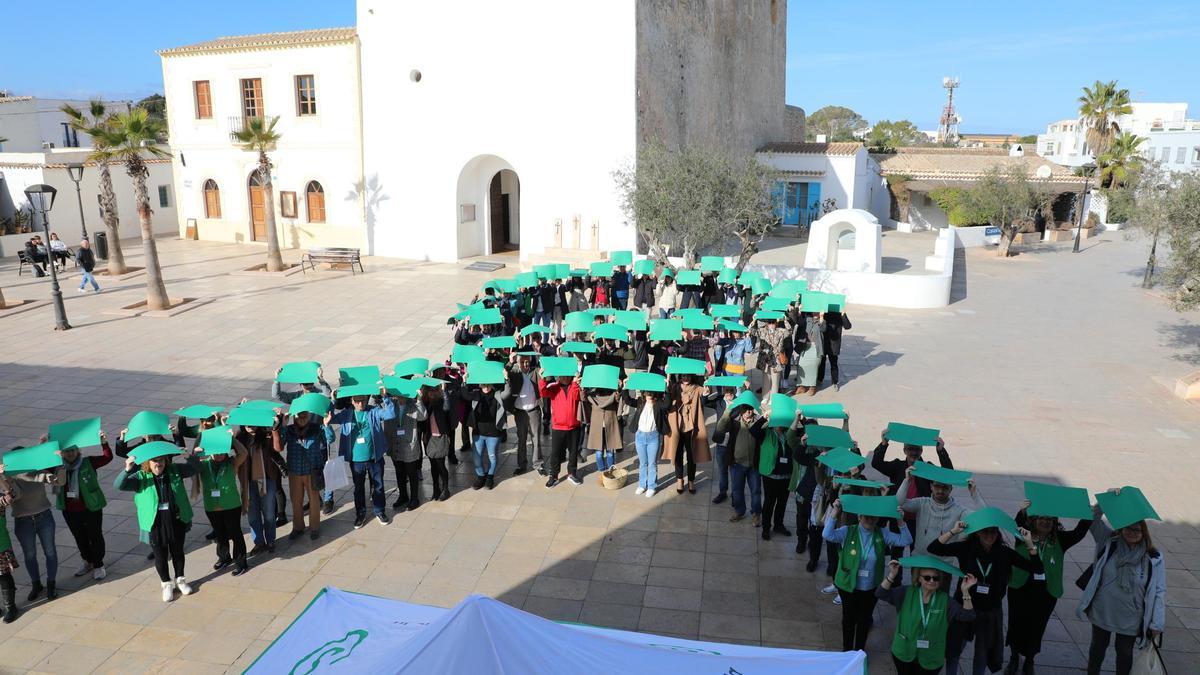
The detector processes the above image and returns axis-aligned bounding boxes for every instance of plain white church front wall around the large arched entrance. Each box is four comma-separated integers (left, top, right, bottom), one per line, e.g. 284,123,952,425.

358,0,636,261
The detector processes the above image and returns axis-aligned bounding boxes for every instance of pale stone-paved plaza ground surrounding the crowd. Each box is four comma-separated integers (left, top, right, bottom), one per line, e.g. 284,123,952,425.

0,233,1200,675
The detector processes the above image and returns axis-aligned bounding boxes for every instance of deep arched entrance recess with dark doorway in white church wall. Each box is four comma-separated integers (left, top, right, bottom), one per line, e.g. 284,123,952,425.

455,155,521,258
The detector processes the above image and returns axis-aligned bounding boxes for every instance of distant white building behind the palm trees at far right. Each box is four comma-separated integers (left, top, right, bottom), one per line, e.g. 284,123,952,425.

1038,102,1200,171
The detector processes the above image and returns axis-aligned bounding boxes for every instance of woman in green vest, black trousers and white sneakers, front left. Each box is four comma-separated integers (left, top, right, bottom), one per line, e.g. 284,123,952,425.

113,444,196,602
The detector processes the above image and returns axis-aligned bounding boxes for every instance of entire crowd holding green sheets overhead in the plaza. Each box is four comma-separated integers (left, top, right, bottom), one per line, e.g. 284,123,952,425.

0,258,1166,674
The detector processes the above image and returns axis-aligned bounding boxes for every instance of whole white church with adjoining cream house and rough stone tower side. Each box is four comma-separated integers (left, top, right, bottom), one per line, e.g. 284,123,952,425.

161,0,786,261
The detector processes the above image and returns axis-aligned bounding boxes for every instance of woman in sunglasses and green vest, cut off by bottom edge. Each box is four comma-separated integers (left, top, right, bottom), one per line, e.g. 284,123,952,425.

875,556,976,675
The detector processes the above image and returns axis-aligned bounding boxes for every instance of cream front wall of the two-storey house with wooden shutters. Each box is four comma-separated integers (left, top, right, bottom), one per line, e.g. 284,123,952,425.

162,38,364,247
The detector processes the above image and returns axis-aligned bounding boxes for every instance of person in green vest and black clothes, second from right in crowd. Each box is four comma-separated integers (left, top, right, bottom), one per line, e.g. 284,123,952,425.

1008,494,1092,675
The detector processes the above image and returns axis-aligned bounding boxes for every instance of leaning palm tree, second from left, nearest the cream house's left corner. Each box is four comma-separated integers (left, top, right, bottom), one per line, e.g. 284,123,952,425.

96,108,170,310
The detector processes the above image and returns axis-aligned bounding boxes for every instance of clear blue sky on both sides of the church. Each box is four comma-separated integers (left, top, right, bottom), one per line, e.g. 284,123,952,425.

0,0,1200,135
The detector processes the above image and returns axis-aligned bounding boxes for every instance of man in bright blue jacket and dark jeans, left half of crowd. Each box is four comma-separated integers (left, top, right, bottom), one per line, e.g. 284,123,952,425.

325,388,396,530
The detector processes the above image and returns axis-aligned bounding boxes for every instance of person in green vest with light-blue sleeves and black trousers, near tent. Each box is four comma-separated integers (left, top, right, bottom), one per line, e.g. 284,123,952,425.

830,497,912,651
